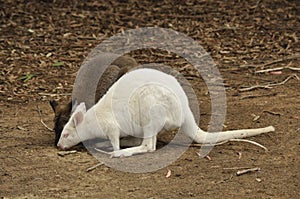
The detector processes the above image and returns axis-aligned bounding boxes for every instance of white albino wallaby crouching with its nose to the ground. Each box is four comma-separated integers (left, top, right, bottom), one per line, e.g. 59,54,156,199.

57,68,275,157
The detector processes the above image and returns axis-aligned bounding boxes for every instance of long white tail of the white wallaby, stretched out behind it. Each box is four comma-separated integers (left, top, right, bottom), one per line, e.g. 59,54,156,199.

181,109,275,144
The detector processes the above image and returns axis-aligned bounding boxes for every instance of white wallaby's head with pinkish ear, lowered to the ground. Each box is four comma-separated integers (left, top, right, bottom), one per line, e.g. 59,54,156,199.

57,103,86,150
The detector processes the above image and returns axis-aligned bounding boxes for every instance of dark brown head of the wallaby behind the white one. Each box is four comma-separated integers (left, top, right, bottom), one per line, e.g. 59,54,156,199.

50,100,72,146
